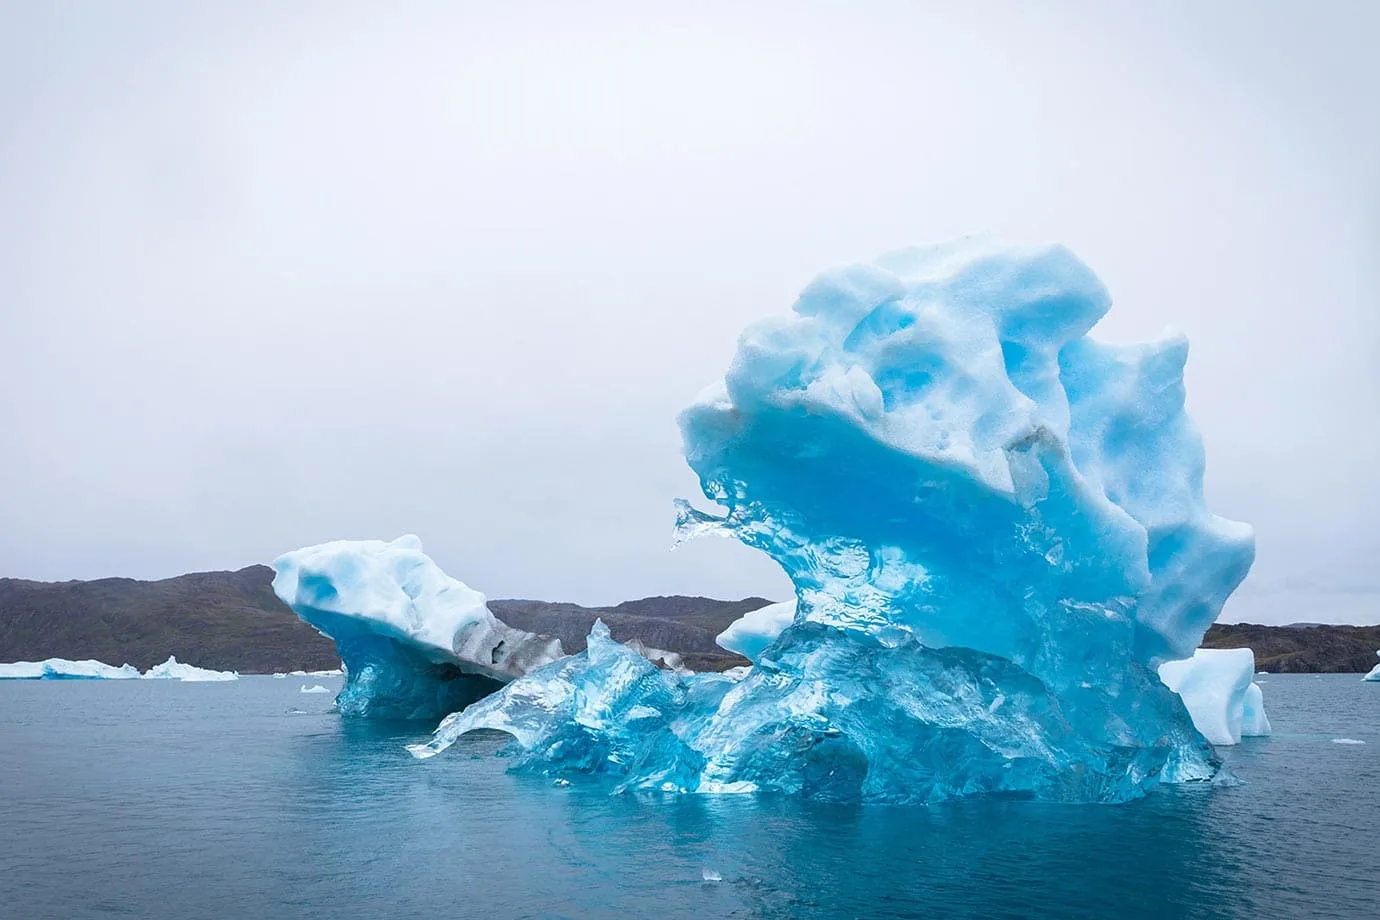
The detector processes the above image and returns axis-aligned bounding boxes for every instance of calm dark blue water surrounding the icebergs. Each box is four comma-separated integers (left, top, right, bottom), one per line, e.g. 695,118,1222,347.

0,674,1380,920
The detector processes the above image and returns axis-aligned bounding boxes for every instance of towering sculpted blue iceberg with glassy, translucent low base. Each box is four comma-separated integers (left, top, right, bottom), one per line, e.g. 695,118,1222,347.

413,239,1254,801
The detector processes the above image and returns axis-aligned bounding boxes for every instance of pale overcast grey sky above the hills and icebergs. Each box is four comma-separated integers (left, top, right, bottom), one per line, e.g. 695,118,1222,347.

0,0,1380,622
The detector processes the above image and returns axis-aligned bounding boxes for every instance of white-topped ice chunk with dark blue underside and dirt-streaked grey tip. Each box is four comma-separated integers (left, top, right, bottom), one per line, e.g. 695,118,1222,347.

273,535,562,719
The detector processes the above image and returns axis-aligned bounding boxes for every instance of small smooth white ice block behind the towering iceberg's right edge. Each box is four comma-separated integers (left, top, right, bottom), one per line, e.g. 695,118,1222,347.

1159,648,1270,745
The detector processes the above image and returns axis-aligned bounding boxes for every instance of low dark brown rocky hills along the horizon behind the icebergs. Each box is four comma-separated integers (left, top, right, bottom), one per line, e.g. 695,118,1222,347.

0,566,1380,673
